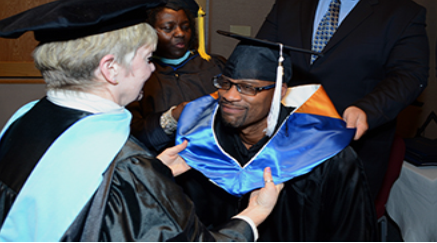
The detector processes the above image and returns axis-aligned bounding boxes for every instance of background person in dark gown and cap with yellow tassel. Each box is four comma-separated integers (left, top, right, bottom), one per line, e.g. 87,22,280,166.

128,0,226,153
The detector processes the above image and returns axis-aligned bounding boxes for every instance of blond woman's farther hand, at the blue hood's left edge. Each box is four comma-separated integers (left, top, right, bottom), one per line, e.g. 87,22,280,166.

156,140,191,177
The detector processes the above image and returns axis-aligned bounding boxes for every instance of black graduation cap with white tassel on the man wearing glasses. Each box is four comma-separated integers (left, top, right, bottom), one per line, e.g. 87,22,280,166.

217,30,321,137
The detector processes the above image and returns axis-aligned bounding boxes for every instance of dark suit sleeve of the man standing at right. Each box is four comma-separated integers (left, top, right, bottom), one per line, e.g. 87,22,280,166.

354,8,430,129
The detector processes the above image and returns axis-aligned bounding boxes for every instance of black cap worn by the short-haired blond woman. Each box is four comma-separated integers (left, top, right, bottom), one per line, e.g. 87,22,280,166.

0,0,167,42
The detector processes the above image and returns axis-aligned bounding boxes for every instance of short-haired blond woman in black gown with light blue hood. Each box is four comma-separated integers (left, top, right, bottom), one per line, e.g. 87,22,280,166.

0,0,281,242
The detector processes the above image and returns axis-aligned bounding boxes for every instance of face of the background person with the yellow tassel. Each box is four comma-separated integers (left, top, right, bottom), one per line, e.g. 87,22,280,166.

153,8,192,59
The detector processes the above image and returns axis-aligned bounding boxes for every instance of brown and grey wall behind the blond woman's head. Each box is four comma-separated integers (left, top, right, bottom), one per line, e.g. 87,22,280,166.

0,0,52,128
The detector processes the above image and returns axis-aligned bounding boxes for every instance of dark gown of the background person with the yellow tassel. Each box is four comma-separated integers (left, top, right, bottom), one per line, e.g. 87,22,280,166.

127,52,226,153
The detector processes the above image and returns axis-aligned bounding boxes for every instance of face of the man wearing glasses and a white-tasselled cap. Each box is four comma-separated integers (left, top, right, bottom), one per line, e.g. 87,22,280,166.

218,79,275,129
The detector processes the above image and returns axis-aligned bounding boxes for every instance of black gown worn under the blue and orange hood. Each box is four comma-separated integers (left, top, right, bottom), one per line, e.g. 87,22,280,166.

176,107,378,242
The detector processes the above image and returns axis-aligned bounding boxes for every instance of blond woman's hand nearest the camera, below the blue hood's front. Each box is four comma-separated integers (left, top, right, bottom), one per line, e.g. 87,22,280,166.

235,167,284,226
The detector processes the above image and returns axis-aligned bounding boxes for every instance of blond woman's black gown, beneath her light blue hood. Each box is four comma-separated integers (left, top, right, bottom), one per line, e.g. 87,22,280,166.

0,98,253,241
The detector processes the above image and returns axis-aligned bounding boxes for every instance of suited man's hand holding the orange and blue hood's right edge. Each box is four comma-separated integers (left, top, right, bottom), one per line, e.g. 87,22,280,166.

343,106,369,141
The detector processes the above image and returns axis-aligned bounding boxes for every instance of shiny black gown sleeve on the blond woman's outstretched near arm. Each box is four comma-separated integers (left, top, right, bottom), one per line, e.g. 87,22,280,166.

101,156,254,242
